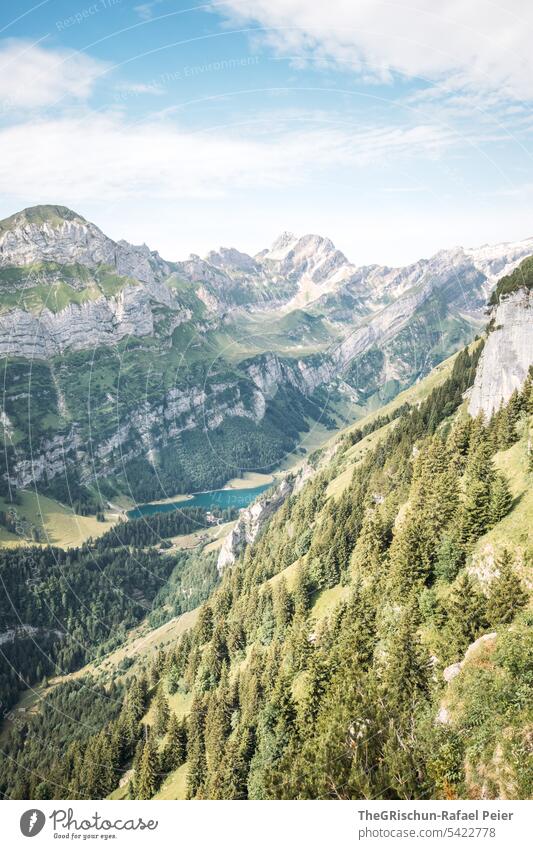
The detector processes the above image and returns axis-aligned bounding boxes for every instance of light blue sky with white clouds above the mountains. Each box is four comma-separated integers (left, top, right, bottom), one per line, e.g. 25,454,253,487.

0,0,533,265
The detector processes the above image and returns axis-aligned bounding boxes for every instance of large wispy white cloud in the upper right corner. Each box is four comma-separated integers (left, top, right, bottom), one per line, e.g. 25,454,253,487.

215,0,533,99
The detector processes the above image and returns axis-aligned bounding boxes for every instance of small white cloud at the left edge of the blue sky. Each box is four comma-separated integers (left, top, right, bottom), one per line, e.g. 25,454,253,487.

0,39,107,110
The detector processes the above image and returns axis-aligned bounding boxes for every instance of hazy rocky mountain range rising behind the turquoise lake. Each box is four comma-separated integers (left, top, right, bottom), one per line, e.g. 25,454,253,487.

0,206,533,500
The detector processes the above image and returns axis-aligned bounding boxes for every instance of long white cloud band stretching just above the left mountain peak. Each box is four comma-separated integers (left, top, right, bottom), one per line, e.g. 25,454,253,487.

0,113,455,203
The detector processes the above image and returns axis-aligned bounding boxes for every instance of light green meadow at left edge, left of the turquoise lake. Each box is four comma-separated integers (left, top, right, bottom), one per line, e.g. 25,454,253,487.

0,490,118,548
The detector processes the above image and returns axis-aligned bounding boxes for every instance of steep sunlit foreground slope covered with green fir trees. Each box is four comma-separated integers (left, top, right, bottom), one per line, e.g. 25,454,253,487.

0,334,533,799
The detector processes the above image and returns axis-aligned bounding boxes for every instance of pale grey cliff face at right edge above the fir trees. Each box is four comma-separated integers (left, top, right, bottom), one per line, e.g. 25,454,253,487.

468,289,533,416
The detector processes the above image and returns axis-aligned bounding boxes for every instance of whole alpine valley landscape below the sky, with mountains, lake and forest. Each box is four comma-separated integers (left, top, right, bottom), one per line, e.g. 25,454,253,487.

0,207,533,799
